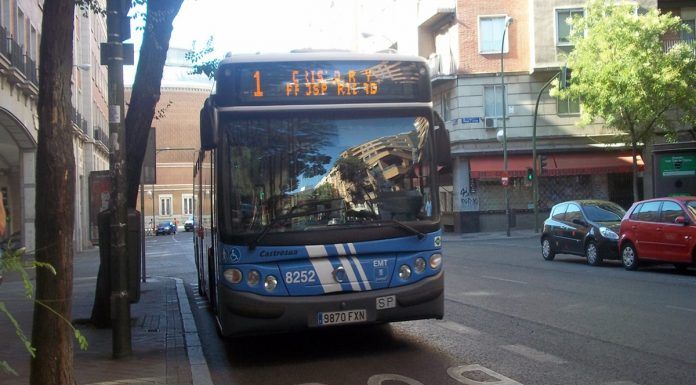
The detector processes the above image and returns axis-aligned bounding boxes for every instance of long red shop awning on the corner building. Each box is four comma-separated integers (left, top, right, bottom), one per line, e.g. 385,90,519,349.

469,152,645,179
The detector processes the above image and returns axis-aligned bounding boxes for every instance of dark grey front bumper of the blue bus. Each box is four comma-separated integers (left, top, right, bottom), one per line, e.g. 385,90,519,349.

218,271,445,337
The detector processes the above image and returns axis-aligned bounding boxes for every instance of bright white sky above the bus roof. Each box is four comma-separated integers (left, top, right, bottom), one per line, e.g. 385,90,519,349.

128,0,416,57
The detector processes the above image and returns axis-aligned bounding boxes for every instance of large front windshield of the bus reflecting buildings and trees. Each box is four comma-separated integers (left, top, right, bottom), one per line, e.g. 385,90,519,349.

218,114,435,242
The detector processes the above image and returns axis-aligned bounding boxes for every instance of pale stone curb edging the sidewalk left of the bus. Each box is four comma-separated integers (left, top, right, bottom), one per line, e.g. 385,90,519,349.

172,278,213,385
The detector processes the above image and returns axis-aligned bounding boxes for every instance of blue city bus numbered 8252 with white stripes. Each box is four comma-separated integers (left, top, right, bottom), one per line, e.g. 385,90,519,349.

193,52,450,337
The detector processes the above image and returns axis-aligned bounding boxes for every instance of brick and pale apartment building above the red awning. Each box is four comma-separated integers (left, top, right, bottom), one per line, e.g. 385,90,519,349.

418,0,657,232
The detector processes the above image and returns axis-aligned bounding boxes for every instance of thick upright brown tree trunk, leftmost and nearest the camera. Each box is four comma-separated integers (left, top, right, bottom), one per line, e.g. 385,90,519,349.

30,0,75,385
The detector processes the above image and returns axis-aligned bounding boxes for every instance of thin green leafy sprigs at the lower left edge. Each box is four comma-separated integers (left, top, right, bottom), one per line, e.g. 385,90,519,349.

0,240,88,375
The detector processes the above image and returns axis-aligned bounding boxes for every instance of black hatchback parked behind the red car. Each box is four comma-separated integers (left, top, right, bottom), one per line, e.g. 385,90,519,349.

541,200,626,266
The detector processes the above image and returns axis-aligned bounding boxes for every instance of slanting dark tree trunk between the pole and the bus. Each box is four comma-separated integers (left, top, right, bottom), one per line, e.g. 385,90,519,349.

126,0,183,209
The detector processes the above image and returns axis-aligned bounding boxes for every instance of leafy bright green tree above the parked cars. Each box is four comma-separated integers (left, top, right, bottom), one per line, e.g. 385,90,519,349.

552,0,696,200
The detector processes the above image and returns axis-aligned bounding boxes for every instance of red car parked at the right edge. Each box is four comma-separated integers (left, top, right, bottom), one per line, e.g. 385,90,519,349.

619,196,696,270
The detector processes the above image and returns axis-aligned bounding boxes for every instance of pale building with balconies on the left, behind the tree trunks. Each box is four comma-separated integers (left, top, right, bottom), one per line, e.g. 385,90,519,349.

0,0,108,251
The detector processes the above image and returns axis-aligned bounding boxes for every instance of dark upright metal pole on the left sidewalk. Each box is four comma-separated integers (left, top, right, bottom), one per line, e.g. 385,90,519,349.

101,0,133,358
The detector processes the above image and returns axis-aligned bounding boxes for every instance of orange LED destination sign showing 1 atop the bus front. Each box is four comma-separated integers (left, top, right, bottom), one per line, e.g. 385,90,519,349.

217,61,430,105
